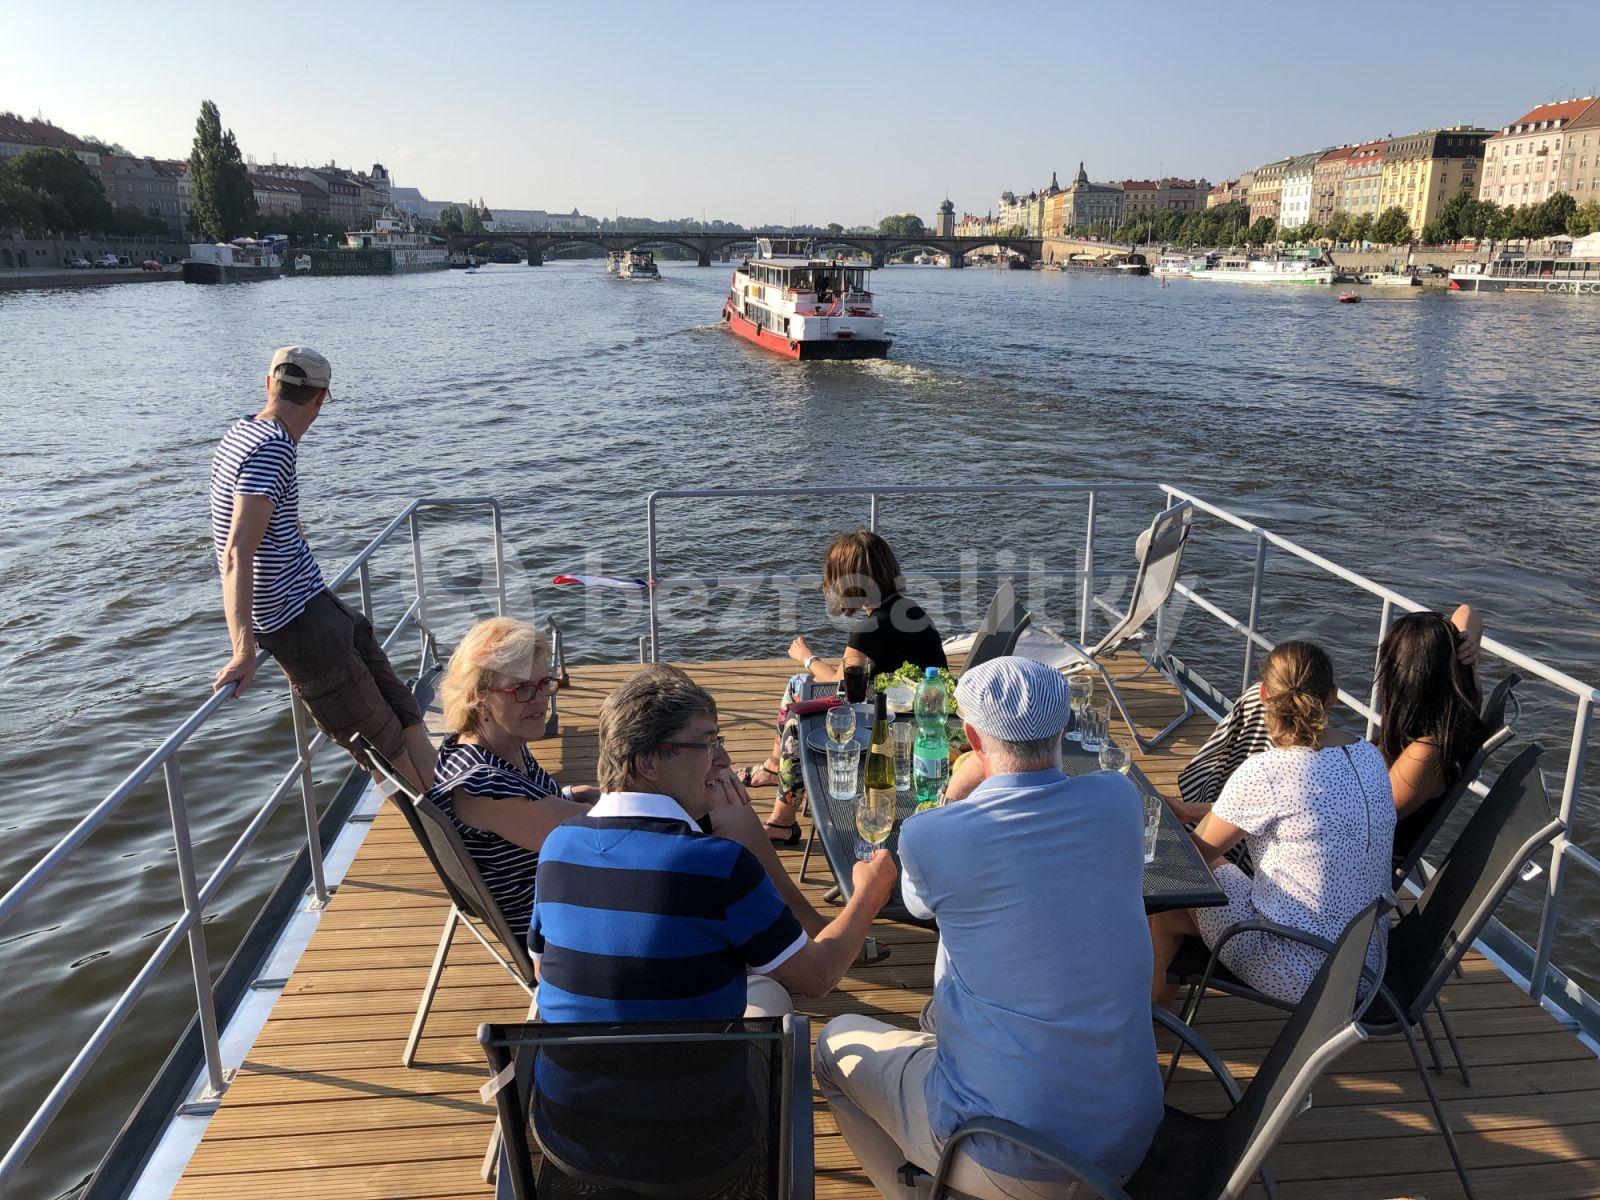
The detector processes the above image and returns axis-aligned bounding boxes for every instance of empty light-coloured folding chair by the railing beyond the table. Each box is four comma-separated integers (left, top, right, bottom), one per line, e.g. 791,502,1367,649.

1014,501,1197,750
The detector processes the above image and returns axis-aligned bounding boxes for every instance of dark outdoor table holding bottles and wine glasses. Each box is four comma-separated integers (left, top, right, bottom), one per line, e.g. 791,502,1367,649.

798,680,1227,925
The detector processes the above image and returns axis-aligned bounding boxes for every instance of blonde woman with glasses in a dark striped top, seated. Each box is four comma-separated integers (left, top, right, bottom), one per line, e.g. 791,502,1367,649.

427,618,827,938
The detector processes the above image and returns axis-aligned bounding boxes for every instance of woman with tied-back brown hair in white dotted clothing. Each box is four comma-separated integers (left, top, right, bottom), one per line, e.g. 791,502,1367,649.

1150,642,1395,1008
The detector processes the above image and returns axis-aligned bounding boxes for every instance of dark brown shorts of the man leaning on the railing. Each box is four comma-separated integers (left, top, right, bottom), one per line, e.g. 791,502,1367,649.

256,590,422,760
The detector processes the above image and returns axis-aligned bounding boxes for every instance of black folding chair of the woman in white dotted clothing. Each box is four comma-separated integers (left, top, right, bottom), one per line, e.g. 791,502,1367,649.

1168,742,1565,1198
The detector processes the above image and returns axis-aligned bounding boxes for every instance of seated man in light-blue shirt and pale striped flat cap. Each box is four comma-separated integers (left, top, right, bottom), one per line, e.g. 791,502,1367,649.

816,658,1162,1200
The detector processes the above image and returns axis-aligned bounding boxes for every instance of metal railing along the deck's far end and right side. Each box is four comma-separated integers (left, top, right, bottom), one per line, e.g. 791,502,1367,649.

640,483,1600,1011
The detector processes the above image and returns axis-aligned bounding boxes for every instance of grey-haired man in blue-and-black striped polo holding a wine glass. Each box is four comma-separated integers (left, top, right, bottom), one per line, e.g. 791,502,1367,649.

528,667,894,1021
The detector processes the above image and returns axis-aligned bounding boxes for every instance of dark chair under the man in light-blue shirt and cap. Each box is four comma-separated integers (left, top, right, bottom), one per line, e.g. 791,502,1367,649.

931,901,1390,1200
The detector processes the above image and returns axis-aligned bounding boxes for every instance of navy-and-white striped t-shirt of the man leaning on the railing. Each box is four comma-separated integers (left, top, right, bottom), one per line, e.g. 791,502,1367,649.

211,416,325,634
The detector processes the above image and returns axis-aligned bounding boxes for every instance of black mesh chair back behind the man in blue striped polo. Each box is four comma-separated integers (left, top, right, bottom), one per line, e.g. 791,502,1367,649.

478,1016,813,1200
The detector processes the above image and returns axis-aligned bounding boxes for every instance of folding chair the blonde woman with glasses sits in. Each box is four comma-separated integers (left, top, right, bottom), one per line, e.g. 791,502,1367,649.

357,736,538,1067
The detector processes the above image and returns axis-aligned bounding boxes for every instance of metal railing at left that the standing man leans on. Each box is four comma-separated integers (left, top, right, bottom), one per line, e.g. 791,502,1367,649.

0,496,506,1192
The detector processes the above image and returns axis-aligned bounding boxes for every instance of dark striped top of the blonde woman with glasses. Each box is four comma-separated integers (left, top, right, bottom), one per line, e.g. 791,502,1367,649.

426,733,562,938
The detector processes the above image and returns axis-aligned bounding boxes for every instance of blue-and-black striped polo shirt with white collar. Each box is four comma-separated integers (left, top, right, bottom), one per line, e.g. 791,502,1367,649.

528,792,806,1021
